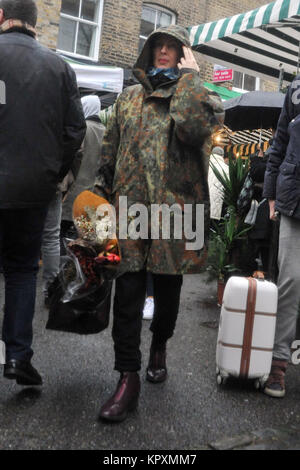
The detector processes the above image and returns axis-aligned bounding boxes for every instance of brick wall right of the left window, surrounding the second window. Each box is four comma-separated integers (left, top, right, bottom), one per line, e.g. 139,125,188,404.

100,0,266,69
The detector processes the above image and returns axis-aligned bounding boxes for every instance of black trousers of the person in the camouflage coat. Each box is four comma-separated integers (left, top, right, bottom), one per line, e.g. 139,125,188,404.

112,271,182,372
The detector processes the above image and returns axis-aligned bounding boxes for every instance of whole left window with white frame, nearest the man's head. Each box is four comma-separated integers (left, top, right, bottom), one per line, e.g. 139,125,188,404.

57,0,103,60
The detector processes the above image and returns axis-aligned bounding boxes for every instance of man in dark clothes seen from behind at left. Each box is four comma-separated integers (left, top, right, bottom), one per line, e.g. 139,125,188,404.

0,0,86,385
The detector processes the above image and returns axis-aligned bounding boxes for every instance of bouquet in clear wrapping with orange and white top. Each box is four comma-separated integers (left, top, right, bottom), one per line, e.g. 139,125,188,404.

52,191,121,302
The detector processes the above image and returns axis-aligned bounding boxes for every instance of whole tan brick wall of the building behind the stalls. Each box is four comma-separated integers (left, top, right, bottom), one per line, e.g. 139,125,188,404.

36,0,276,90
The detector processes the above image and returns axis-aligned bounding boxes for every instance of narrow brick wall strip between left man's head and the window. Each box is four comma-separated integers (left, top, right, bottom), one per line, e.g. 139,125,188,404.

36,0,61,49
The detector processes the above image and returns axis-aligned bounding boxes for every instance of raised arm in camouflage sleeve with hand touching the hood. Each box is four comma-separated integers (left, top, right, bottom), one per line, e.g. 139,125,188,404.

170,47,224,146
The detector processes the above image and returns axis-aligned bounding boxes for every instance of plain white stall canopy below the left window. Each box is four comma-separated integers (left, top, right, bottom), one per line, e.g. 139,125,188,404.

62,55,124,93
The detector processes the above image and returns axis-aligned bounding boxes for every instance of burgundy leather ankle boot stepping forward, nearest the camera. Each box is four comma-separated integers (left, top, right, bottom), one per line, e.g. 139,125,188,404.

99,372,140,422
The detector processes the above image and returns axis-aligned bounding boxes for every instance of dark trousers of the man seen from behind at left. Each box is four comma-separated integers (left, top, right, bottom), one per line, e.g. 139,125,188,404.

0,207,47,361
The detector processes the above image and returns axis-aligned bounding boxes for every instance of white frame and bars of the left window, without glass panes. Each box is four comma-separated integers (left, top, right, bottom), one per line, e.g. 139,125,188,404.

56,0,104,62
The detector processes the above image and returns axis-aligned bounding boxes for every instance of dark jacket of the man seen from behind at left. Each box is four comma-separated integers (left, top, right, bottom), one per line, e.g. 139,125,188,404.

0,28,86,209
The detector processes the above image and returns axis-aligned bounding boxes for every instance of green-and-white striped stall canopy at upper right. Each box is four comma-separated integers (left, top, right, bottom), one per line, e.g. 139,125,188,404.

188,0,300,84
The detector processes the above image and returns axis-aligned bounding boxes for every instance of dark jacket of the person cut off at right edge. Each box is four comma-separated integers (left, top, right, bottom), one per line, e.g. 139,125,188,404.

263,75,300,218
